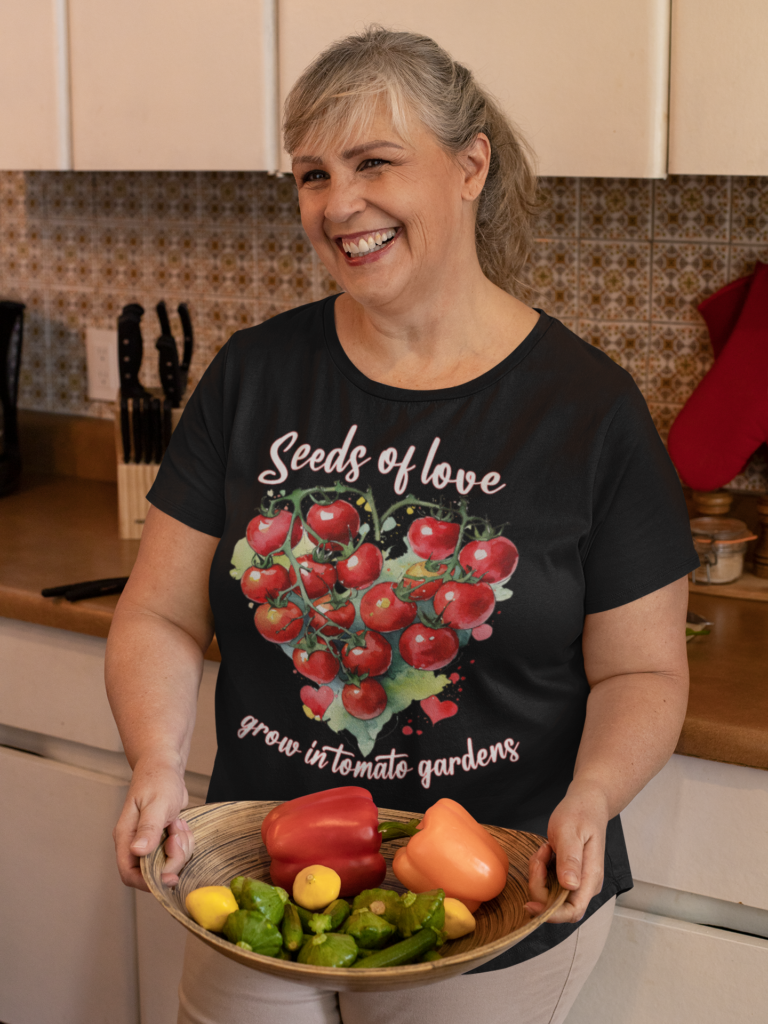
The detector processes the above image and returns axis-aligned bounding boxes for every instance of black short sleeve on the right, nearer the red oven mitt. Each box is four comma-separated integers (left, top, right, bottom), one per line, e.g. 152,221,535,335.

582,386,698,614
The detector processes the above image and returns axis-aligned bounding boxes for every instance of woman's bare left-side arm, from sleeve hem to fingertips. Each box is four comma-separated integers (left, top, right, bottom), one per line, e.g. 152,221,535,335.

105,508,218,889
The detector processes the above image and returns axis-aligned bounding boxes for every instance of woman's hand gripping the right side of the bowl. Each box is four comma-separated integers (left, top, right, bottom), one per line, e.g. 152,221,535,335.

525,780,608,925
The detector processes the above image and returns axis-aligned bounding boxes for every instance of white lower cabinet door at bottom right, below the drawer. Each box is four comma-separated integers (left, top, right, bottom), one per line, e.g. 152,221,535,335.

566,907,768,1024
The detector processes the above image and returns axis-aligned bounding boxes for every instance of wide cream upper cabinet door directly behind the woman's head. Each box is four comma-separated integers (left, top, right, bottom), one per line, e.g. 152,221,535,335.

280,0,671,177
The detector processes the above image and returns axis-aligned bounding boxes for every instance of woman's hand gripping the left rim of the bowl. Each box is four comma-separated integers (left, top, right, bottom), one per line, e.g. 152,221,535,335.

113,759,195,892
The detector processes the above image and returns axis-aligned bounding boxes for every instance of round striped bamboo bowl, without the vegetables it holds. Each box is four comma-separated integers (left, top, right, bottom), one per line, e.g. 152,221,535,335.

140,801,568,991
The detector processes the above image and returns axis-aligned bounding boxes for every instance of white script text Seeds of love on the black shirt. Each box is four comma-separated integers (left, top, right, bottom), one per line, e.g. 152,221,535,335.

258,424,506,495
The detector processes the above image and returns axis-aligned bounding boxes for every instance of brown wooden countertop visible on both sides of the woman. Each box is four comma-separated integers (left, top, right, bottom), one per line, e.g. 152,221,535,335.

0,477,768,769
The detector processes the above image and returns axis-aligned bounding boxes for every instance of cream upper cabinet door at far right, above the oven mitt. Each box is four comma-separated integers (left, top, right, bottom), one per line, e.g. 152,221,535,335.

670,0,768,175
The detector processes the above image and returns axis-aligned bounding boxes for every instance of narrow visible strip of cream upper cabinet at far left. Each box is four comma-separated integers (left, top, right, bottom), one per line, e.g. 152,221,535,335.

0,0,71,171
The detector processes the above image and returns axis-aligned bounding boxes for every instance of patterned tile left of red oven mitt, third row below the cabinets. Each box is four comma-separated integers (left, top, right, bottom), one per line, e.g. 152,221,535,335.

645,324,713,406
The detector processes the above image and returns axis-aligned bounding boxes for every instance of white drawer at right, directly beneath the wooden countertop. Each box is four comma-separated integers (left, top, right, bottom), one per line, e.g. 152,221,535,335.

622,754,768,910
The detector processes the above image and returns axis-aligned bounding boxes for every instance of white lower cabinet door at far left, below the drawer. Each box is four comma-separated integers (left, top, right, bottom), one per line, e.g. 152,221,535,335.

0,746,138,1024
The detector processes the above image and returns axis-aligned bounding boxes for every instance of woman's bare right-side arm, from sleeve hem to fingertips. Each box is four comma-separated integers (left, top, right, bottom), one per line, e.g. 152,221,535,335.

527,578,688,924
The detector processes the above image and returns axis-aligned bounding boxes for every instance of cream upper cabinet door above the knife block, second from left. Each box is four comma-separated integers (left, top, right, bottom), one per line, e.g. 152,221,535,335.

66,0,278,171
